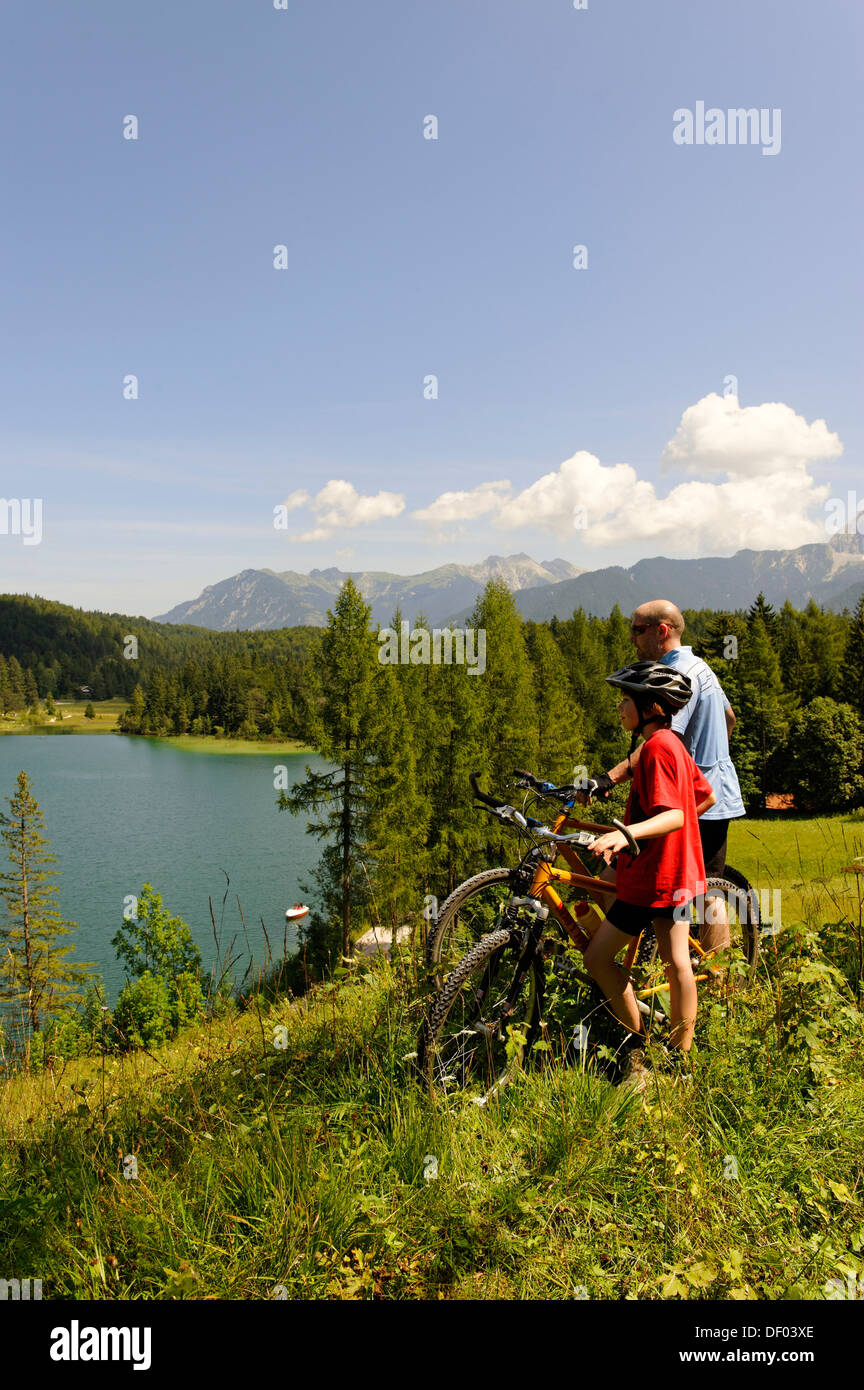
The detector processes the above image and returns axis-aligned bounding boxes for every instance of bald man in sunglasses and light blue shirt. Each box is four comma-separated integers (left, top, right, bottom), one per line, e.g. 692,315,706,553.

586,599,745,951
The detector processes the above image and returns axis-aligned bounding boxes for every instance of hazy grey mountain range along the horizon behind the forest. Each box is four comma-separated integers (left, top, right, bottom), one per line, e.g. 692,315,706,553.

156,534,864,631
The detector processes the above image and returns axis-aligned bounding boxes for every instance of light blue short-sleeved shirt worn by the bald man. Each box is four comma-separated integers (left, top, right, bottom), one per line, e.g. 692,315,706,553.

660,646,745,820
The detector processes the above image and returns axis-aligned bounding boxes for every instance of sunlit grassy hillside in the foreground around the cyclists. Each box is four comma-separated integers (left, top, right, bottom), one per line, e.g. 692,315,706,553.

0,817,864,1300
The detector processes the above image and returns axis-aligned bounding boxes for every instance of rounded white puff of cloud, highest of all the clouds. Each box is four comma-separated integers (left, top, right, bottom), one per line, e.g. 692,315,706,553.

661,393,843,477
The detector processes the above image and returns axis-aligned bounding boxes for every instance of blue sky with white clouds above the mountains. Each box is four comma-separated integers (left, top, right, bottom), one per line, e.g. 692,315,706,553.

0,0,864,614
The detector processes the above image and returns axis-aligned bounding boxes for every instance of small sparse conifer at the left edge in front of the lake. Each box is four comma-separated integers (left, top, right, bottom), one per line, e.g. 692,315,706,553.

0,771,90,1033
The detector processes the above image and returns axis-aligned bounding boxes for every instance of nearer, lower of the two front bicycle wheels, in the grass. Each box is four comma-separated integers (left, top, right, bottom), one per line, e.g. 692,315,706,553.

417,930,543,1104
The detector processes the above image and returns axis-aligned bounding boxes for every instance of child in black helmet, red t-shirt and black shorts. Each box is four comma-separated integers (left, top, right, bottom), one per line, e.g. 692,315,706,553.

585,662,714,1090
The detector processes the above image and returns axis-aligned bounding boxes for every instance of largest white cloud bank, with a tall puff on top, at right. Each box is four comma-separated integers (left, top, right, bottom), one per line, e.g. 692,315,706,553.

413,395,843,556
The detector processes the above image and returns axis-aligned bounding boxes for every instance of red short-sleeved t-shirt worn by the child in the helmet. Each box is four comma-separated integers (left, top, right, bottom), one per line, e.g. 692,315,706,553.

615,728,711,908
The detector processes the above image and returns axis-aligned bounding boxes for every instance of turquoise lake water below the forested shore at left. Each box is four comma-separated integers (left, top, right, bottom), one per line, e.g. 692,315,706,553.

0,734,326,1002
